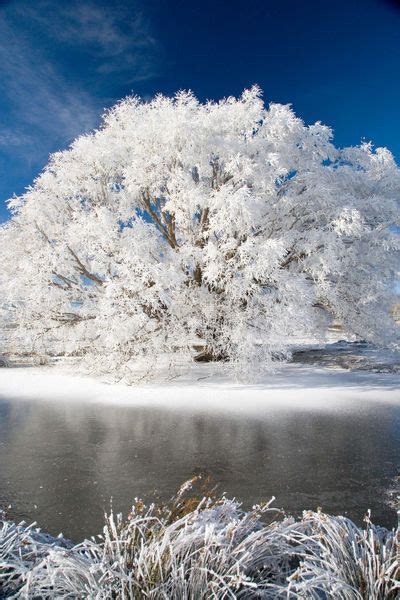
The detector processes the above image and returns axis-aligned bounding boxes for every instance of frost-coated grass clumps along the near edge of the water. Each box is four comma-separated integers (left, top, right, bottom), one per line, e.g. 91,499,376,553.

0,477,400,600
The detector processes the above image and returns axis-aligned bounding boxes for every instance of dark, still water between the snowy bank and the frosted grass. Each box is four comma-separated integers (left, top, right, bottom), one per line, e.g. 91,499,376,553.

0,398,400,541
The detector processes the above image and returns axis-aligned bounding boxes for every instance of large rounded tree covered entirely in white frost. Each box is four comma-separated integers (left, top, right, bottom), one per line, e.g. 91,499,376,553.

0,87,400,375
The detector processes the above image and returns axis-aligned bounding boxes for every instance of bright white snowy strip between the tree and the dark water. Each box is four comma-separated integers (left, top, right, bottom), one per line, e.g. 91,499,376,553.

0,364,400,412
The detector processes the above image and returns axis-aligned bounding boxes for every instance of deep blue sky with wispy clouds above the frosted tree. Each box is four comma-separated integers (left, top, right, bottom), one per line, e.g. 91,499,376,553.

0,0,400,221
